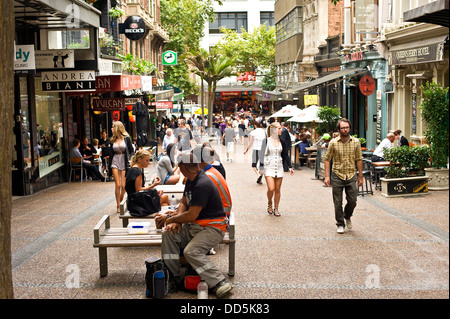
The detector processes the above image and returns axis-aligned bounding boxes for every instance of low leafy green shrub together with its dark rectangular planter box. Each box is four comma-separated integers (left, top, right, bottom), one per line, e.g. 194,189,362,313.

380,145,431,197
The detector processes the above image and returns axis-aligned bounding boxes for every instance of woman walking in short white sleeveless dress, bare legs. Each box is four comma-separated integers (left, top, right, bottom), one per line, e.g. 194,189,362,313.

264,122,294,217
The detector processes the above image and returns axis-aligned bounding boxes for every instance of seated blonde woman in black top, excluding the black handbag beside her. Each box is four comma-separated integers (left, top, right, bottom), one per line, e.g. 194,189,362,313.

125,150,170,211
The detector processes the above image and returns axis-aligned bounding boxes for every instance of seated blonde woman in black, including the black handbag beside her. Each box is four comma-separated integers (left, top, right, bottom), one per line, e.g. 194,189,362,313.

125,150,170,216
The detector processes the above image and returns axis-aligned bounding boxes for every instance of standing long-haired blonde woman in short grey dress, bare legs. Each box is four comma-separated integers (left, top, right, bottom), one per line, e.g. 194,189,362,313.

109,121,134,212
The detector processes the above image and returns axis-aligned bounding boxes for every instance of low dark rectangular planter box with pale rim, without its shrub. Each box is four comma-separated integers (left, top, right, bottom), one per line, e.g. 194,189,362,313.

380,176,428,197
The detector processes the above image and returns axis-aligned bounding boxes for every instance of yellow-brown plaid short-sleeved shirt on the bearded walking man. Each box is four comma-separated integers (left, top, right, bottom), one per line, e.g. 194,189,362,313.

324,136,363,180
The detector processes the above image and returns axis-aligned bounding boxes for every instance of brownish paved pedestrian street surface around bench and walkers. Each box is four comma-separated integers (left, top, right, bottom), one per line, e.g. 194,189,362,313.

12,144,449,299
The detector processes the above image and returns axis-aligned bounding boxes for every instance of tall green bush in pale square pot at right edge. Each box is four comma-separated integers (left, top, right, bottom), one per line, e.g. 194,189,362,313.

420,82,450,190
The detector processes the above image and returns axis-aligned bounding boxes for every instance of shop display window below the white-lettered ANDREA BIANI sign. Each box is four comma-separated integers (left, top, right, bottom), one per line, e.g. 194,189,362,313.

35,78,64,178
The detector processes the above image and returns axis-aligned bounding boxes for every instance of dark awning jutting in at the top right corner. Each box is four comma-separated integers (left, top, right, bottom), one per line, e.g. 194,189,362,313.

403,0,449,28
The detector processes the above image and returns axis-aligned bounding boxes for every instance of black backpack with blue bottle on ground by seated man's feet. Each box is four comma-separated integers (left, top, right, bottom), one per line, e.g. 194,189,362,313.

145,257,169,299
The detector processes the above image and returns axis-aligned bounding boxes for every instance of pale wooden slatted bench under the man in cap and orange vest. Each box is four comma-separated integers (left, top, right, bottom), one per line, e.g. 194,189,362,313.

94,212,236,277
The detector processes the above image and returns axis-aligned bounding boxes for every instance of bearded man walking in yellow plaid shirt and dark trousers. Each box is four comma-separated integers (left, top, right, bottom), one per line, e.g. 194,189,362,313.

324,118,363,234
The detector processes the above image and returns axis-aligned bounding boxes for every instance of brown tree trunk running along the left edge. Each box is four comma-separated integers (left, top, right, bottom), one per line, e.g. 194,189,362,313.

0,1,15,299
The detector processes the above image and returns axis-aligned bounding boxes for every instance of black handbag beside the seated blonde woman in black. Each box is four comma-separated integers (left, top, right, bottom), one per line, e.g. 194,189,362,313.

128,188,161,217
